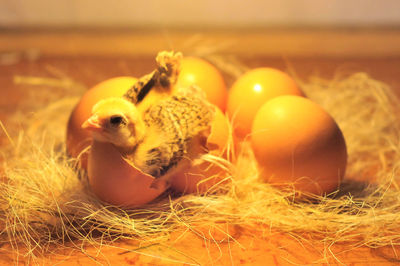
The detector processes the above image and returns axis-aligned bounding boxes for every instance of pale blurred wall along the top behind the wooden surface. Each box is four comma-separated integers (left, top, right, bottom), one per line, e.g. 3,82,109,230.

0,0,400,28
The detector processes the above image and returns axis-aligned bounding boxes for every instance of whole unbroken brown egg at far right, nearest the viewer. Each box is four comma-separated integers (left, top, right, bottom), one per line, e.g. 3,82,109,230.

251,95,347,195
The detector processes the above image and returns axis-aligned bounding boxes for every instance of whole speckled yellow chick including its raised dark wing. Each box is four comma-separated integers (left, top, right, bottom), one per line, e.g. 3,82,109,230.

83,51,215,188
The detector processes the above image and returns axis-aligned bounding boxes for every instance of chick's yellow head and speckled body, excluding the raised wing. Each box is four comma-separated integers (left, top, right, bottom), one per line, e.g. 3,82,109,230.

82,95,215,188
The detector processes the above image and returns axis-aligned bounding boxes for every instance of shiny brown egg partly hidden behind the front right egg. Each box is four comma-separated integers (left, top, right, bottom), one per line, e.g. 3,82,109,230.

227,67,304,138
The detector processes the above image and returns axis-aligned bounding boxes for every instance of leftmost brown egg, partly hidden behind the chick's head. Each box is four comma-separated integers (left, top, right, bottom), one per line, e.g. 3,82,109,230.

67,77,137,169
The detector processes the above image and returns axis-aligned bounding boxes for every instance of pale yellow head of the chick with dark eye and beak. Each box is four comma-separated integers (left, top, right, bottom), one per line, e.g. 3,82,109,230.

82,98,145,150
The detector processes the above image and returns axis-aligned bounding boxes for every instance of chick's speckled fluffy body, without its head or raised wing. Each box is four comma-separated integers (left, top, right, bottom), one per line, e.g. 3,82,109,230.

128,96,214,177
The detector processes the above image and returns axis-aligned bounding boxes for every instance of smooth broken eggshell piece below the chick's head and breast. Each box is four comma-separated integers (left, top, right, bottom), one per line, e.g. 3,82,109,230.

88,141,167,207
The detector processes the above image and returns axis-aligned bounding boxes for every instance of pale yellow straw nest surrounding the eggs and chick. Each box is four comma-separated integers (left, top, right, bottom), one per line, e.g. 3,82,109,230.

0,58,400,264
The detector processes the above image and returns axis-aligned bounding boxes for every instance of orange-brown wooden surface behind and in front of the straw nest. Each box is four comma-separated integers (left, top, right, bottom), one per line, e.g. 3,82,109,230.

0,30,400,265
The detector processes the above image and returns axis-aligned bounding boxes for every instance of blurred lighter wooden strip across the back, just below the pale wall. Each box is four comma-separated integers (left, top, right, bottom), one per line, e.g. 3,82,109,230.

0,29,400,58
